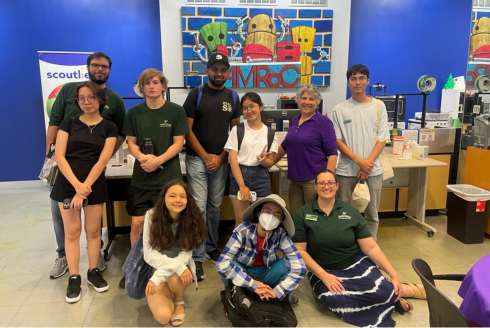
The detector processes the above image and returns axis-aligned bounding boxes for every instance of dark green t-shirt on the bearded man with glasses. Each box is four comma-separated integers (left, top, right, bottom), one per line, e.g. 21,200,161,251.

49,82,126,139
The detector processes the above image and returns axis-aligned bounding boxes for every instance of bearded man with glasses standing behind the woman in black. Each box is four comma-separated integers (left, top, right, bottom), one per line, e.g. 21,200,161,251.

46,52,126,279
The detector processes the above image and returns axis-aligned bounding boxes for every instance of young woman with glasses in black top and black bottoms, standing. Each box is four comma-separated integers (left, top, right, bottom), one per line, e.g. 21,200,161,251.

51,81,117,303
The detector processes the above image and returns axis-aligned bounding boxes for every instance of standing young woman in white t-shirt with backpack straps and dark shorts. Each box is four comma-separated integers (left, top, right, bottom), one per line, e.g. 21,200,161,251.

225,92,278,227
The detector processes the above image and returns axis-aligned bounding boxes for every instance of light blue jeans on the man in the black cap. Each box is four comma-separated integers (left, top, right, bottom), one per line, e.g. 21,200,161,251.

185,155,229,262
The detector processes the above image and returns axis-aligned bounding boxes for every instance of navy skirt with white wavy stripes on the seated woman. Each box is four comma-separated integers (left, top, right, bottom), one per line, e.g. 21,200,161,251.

308,253,397,327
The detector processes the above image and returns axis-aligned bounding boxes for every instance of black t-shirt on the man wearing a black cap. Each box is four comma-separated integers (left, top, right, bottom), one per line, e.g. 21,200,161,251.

183,83,242,156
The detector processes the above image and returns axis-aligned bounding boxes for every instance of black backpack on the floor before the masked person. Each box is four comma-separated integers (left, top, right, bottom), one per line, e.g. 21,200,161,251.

220,282,298,327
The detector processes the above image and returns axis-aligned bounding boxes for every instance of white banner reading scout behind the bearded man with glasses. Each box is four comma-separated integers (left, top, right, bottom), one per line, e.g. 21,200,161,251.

38,51,91,131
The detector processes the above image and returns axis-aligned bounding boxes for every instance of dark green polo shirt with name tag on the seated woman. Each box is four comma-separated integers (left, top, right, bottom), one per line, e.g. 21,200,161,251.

292,199,371,270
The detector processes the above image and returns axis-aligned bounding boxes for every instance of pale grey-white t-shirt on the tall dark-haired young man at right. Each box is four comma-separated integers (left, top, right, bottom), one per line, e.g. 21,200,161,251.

332,98,390,176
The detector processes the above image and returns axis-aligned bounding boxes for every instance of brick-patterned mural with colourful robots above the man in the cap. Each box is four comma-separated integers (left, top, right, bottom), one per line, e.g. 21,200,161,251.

181,6,333,88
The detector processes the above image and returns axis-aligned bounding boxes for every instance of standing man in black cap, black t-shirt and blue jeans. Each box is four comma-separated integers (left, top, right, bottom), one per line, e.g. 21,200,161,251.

184,54,242,281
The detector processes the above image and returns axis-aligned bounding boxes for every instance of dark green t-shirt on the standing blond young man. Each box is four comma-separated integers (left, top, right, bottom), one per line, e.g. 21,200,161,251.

124,101,189,190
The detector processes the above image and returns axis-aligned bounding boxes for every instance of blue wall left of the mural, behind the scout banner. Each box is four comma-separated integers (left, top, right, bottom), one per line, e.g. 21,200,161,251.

0,0,162,182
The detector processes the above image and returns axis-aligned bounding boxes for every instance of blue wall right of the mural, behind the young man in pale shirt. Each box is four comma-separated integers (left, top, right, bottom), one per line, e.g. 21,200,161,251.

347,0,472,119
